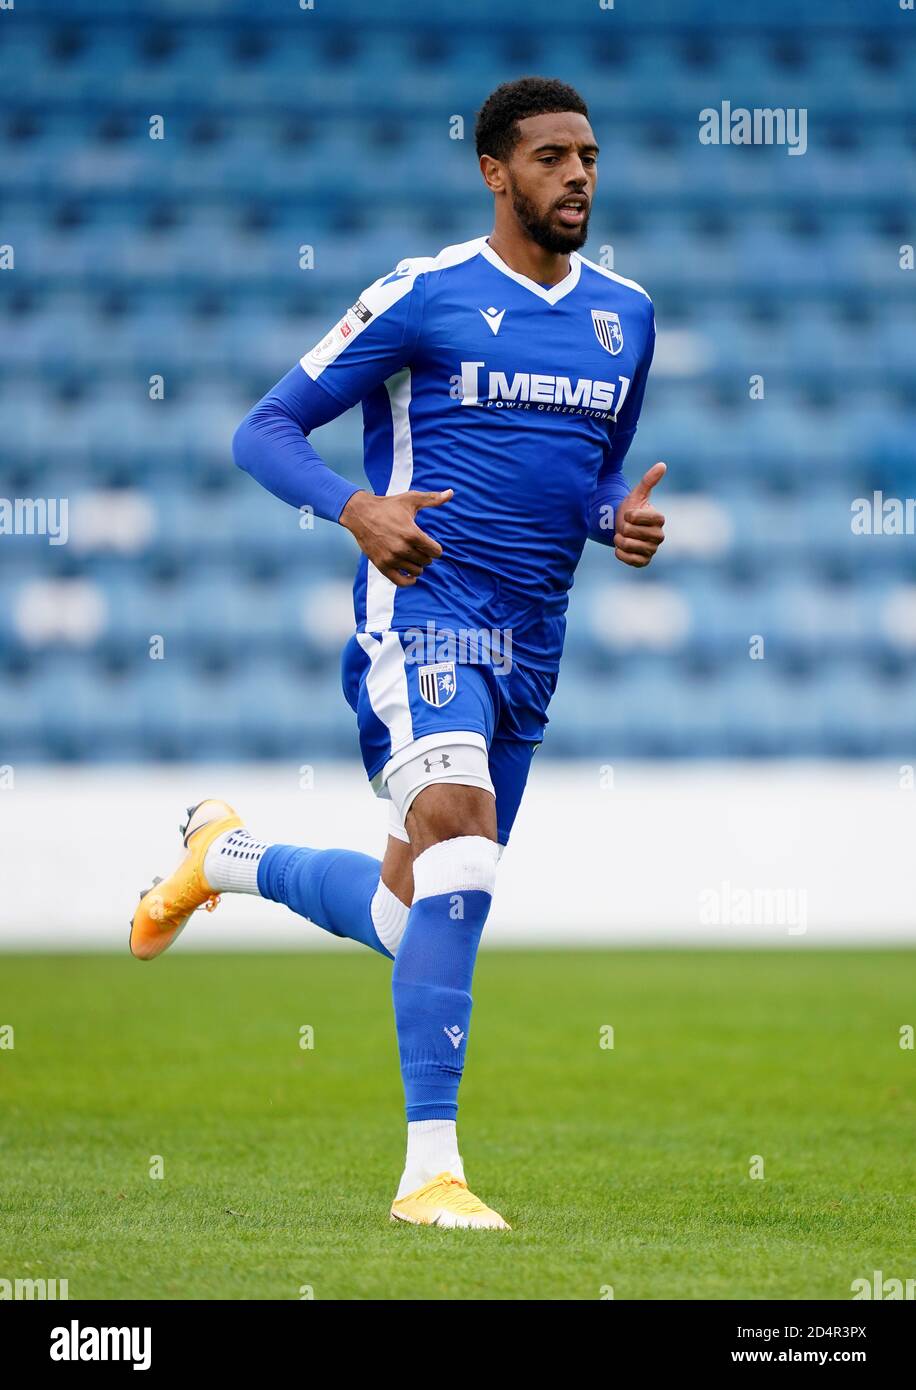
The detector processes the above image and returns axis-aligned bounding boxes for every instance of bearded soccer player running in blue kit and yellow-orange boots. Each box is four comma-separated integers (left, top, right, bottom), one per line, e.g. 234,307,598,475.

131,78,666,1229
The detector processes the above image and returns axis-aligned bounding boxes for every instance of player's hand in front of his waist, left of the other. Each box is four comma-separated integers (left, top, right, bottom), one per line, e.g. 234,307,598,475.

339,488,455,589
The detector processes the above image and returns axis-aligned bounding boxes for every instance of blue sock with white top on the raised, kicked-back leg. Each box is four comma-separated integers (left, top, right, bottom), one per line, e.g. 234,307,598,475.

257,845,407,960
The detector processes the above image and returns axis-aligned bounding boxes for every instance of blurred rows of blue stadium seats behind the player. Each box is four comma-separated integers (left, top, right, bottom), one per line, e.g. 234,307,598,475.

0,0,916,762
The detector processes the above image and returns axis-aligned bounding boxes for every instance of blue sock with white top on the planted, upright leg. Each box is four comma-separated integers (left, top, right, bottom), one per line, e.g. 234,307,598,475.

392,835,498,1120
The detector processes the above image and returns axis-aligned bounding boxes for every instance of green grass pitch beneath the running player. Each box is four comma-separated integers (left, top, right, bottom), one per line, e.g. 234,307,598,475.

0,945,916,1300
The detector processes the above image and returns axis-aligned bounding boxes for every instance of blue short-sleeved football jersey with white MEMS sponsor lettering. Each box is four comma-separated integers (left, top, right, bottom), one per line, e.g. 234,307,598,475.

302,236,655,670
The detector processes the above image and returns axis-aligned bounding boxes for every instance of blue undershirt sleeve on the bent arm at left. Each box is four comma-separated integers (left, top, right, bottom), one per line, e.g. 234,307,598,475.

232,366,360,521
